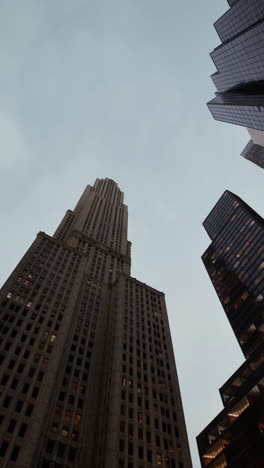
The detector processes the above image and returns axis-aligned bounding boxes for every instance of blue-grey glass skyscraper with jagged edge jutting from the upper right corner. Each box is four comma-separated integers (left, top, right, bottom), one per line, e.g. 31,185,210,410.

208,0,264,167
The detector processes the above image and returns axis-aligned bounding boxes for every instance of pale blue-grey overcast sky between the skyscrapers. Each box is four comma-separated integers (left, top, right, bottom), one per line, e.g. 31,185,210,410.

0,0,263,468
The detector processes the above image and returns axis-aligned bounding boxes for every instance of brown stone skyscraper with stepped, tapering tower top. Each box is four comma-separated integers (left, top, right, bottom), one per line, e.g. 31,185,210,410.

0,179,191,468
